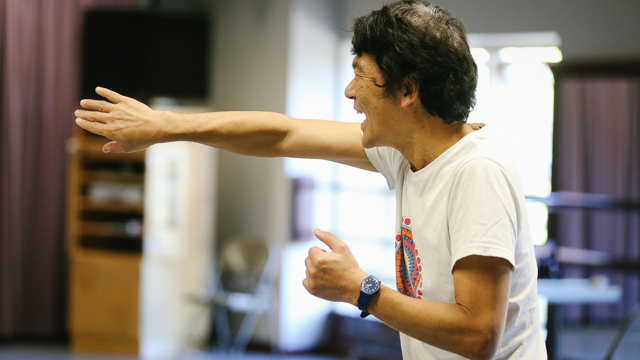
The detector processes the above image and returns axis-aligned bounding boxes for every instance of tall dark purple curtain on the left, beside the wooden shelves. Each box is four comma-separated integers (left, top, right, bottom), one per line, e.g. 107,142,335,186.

0,0,137,339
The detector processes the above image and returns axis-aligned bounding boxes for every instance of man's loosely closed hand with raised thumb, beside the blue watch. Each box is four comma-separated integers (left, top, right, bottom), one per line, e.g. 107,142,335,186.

302,229,367,306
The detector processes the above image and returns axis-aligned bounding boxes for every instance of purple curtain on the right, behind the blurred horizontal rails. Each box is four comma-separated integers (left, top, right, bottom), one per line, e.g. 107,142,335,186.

553,64,640,323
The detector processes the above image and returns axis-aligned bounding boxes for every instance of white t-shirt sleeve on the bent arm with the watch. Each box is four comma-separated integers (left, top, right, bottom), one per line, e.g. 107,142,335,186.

448,157,521,271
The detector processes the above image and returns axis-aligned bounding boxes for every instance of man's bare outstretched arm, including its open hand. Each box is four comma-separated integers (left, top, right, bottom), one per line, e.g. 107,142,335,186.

75,88,375,171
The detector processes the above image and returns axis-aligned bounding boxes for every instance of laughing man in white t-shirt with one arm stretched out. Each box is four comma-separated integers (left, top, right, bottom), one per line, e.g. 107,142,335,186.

76,0,546,359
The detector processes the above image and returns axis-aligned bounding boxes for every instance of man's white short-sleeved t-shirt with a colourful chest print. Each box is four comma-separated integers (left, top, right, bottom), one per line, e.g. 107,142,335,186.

367,127,547,360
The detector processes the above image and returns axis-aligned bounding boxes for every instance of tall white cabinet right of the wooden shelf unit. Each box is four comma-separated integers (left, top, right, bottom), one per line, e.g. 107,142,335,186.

138,103,217,360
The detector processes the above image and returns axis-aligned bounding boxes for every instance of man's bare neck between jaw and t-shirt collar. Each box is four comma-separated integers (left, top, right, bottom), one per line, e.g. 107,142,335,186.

396,115,473,171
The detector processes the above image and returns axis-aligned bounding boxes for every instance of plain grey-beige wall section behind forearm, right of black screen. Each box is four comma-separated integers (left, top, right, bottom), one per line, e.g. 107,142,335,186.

212,0,289,252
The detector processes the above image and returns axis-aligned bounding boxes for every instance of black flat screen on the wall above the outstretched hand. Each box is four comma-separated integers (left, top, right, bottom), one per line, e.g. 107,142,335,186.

81,10,210,101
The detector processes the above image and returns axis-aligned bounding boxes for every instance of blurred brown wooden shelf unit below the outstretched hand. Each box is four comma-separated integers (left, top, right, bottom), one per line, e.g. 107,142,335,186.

67,129,145,353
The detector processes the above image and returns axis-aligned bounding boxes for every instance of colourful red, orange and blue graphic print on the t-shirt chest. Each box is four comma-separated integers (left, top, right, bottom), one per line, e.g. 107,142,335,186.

396,216,423,299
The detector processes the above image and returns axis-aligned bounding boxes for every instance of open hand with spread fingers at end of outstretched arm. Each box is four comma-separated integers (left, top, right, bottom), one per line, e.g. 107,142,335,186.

75,87,166,152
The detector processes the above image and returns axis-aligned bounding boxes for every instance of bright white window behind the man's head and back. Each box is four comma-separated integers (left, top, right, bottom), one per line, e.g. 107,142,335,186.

469,33,562,245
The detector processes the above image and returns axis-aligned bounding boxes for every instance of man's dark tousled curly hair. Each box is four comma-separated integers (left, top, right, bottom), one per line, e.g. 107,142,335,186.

351,0,478,124
